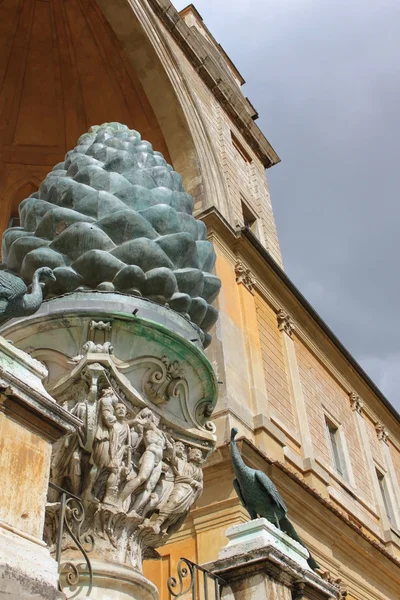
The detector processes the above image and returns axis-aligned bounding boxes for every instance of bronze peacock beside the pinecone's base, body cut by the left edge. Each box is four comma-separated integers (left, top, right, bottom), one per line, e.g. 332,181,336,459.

0,267,55,323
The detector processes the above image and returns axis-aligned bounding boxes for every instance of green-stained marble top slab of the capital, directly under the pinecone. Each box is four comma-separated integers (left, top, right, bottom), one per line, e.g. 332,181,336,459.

0,291,218,440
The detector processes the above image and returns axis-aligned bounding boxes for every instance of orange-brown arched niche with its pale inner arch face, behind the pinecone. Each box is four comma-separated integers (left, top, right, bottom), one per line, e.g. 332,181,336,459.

0,0,206,239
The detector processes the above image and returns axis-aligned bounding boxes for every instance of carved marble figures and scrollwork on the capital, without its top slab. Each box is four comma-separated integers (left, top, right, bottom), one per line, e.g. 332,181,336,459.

46,341,209,570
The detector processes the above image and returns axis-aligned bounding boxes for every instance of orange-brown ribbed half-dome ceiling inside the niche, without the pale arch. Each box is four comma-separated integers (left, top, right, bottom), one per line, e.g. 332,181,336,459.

0,0,170,232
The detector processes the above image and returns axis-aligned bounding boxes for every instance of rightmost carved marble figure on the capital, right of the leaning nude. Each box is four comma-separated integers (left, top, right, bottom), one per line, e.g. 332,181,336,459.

154,442,203,534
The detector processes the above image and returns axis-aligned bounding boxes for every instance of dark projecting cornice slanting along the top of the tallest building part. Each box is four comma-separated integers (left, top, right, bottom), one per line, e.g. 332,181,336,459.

148,0,280,168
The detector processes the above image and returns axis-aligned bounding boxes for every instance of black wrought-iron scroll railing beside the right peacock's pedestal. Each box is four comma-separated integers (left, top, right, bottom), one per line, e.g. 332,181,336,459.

167,558,226,600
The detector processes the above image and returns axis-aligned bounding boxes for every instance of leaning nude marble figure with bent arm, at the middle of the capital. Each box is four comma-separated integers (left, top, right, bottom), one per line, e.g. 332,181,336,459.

119,408,166,511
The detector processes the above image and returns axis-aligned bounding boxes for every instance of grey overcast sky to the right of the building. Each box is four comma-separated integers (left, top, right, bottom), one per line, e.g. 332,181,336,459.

174,0,400,411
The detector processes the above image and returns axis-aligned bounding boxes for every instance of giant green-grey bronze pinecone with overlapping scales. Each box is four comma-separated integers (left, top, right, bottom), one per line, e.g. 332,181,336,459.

3,123,219,341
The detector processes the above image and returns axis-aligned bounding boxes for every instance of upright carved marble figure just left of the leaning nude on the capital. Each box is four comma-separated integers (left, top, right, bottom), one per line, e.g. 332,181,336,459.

82,387,118,501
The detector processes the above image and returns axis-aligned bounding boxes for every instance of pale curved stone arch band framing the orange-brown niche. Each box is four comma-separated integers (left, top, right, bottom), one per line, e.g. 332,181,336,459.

97,0,230,214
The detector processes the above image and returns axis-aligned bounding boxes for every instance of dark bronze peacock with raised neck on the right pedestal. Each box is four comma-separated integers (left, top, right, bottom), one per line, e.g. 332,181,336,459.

230,427,319,570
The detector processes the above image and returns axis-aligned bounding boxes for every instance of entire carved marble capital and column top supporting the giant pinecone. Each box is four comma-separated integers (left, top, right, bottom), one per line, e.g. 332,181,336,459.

0,291,217,600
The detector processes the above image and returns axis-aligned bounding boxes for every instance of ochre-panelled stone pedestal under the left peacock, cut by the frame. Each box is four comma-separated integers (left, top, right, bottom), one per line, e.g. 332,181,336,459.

0,337,80,600
